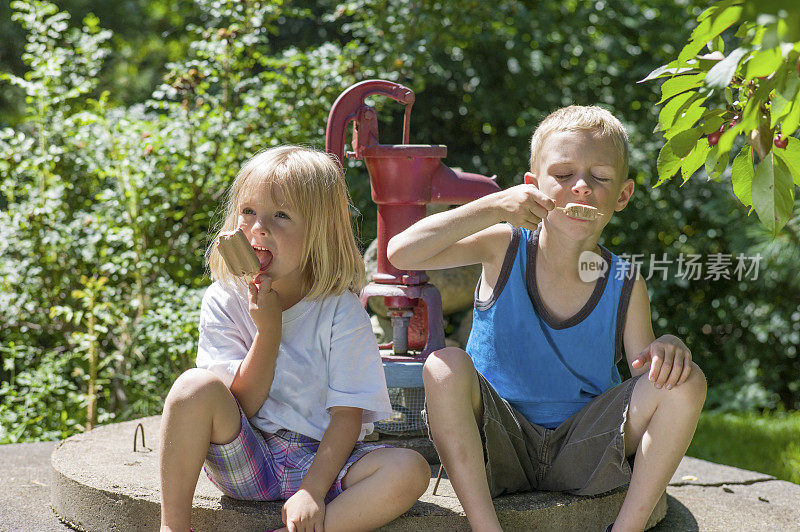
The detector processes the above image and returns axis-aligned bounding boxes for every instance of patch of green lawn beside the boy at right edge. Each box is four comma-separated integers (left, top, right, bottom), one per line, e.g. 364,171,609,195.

686,410,800,484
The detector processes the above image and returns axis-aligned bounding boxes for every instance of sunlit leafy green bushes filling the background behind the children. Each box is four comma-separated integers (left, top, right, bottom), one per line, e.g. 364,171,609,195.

0,0,800,442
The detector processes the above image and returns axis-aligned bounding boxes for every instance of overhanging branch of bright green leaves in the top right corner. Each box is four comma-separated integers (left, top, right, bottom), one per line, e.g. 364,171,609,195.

643,0,800,235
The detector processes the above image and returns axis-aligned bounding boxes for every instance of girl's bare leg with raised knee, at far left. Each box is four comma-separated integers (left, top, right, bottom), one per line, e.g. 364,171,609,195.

158,369,241,531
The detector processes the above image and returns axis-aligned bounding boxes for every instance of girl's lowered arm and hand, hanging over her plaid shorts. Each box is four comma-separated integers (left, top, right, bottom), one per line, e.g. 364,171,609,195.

283,406,362,530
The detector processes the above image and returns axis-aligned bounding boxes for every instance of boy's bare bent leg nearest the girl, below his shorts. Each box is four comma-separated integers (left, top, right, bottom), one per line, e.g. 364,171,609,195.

422,347,501,531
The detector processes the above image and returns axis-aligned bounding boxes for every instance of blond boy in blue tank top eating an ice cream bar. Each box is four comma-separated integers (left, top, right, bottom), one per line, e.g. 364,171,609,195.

388,106,706,531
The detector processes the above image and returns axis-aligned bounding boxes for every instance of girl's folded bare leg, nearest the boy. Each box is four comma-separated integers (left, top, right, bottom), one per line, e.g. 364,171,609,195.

270,448,431,532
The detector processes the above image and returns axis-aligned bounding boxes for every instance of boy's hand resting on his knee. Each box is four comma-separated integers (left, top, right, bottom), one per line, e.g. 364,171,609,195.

631,334,692,390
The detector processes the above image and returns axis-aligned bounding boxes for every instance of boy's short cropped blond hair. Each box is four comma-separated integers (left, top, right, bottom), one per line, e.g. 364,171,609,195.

531,105,629,179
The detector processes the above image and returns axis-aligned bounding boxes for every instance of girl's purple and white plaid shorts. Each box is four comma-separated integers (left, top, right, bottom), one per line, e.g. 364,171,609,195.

203,407,390,504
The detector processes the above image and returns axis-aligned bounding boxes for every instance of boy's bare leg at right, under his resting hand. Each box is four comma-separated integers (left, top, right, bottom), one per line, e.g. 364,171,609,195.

614,363,706,531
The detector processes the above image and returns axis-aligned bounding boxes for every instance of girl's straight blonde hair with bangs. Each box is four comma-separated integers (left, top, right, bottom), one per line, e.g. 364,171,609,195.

206,146,365,300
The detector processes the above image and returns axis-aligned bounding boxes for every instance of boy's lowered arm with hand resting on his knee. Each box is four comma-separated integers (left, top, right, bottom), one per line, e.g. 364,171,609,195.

622,273,692,389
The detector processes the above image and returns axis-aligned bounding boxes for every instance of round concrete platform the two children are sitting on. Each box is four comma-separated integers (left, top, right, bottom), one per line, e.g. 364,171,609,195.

48,416,667,532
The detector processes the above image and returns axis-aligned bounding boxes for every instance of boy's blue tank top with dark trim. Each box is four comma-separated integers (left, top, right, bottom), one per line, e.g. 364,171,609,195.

466,225,636,428
